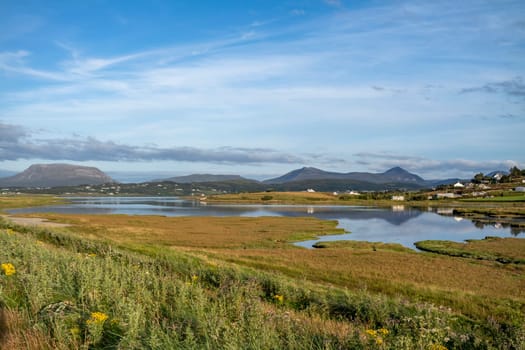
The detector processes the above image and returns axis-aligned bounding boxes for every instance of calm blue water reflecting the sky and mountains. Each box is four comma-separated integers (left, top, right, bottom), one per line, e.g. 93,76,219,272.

10,197,524,248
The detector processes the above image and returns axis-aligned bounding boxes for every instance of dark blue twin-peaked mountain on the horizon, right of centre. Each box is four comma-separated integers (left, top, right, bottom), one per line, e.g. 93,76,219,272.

264,167,426,187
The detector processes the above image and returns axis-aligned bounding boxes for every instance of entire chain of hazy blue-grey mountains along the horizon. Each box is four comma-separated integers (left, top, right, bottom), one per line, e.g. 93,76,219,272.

0,164,458,192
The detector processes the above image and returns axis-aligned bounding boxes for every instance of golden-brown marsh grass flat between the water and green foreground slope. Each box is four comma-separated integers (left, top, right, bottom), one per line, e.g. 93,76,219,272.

26,214,525,299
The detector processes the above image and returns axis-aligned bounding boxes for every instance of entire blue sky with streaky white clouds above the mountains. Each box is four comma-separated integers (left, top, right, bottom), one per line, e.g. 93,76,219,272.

0,0,525,179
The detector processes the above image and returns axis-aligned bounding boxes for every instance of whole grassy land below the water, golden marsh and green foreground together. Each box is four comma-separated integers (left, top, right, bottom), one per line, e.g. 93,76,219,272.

0,196,525,349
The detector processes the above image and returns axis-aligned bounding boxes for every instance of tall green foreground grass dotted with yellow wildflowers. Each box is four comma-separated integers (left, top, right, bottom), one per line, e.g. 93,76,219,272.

0,222,525,349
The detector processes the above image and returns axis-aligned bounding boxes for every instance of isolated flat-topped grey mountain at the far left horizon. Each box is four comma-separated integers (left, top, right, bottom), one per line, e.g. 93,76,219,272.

0,164,115,187
